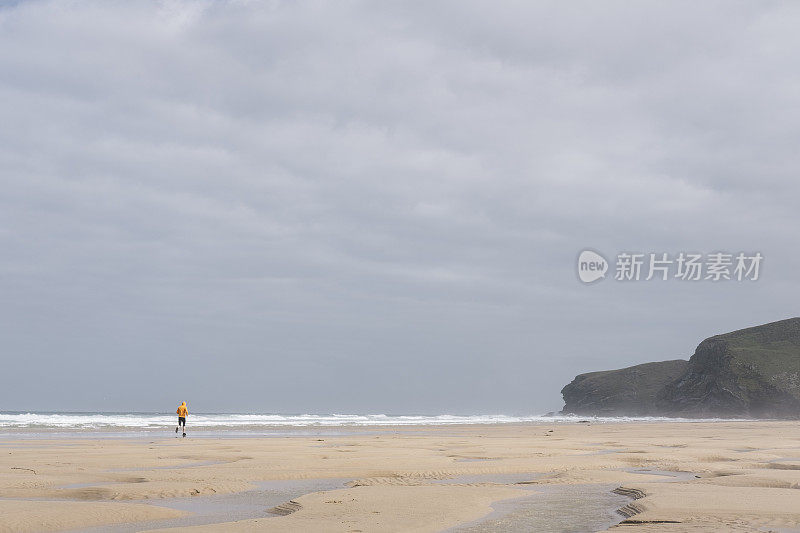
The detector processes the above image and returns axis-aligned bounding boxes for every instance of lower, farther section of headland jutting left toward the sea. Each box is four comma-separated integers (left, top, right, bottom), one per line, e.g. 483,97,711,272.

561,359,689,416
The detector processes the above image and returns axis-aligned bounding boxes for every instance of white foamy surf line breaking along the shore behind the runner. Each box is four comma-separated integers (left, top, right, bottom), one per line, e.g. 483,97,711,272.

0,412,748,430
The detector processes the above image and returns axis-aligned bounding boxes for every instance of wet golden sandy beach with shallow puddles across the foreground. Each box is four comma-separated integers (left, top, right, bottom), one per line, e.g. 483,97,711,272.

0,422,800,532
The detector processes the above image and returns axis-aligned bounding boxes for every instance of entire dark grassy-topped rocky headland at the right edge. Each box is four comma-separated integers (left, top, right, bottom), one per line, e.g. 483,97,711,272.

561,318,800,418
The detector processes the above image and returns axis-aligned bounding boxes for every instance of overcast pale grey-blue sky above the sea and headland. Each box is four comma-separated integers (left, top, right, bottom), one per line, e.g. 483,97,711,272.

0,0,800,414
